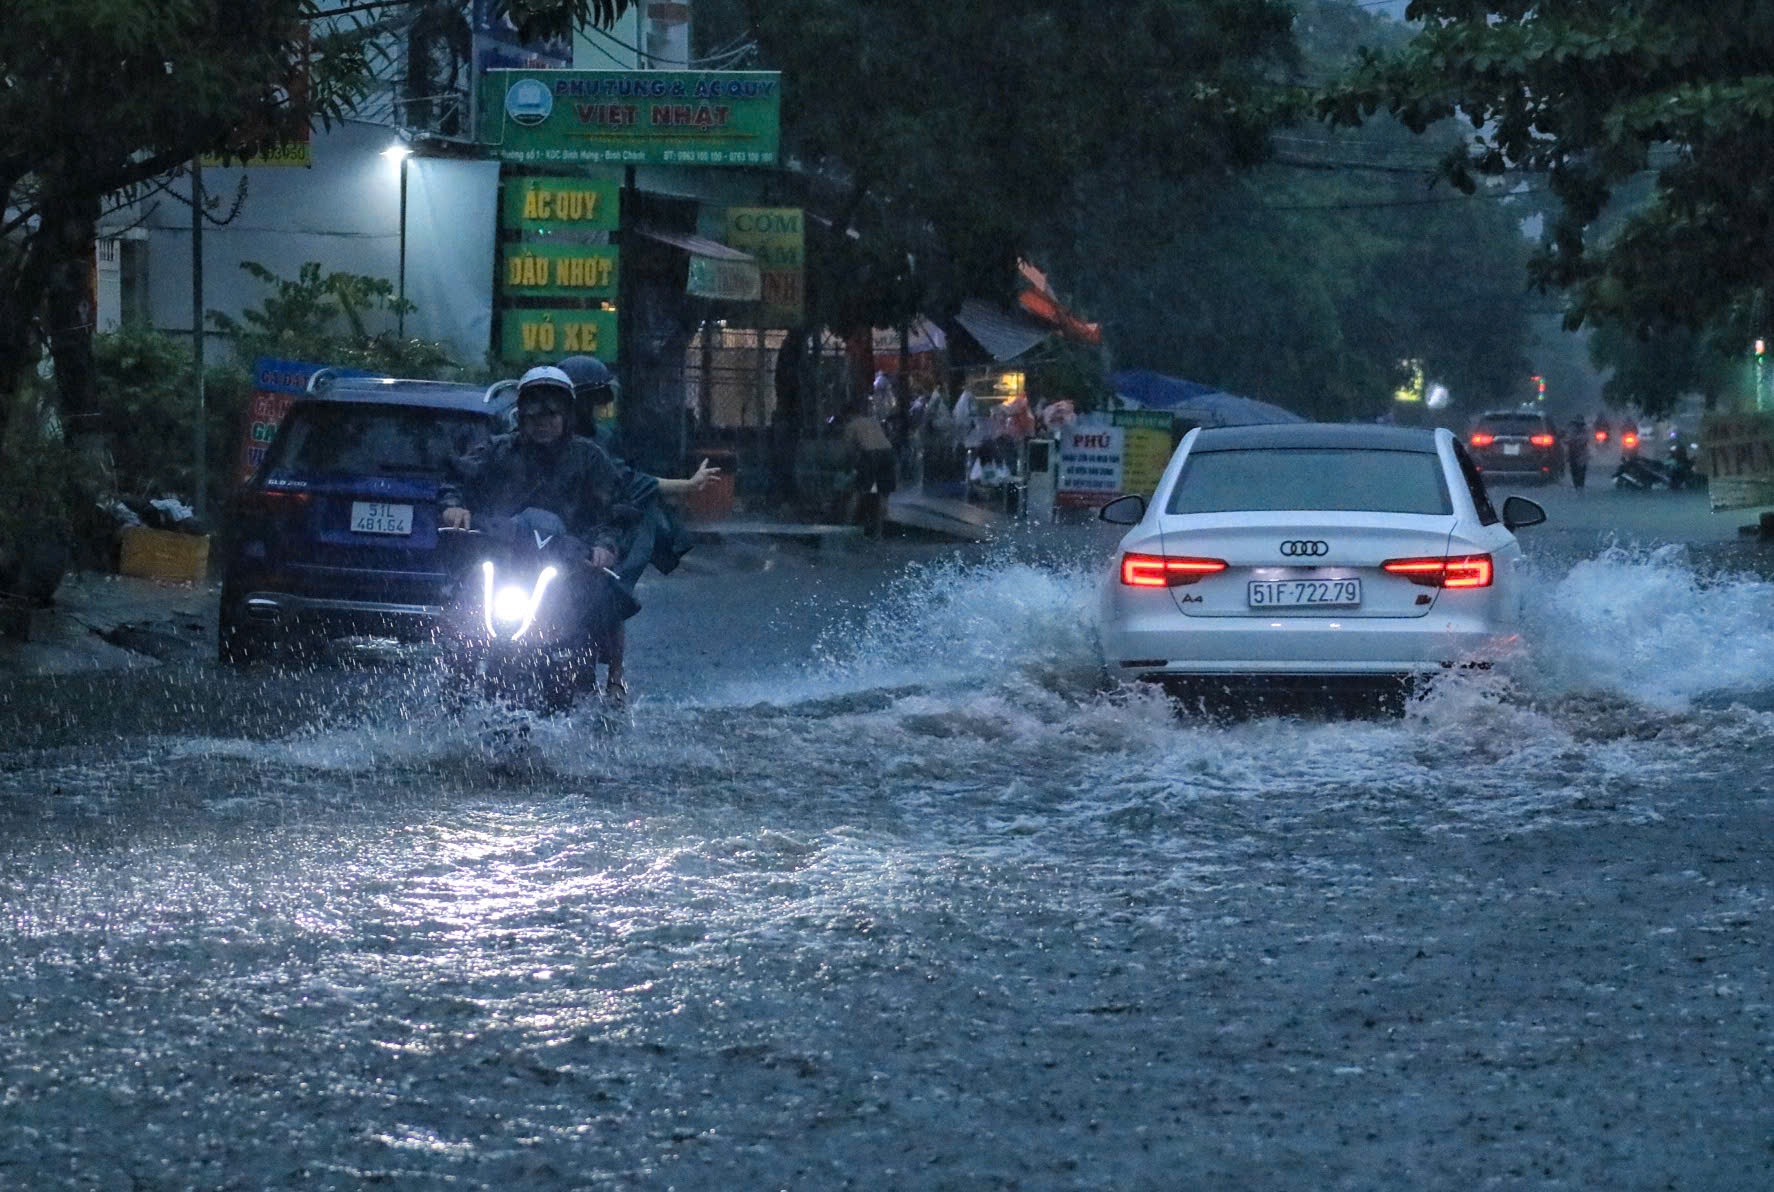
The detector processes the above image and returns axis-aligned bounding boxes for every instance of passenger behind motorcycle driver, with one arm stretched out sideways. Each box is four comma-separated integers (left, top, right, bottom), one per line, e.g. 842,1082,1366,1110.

559,357,720,702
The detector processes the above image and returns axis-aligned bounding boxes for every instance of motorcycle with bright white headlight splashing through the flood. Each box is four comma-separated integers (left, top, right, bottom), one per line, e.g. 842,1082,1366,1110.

438,509,637,715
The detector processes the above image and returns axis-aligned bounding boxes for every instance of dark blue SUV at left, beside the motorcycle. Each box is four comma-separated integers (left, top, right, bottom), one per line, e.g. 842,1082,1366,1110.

216,378,513,665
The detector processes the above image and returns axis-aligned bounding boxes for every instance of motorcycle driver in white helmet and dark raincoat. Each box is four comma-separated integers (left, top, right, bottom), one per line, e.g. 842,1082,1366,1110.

438,365,639,699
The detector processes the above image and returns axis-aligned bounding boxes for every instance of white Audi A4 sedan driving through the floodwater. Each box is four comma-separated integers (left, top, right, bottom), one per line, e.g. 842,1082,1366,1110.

1100,424,1545,688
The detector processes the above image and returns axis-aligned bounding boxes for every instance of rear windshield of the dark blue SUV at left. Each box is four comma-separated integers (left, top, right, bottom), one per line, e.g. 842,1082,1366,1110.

266,404,491,477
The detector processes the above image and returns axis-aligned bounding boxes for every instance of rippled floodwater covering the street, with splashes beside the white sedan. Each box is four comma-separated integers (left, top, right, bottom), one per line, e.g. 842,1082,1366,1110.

0,548,1774,1188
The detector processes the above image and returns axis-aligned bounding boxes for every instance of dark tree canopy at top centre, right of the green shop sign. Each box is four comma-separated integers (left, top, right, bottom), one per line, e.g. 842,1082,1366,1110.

747,0,1291,325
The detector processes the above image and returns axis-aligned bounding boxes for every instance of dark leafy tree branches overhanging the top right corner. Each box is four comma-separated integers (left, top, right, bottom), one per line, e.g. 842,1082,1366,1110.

1322,0,1774,332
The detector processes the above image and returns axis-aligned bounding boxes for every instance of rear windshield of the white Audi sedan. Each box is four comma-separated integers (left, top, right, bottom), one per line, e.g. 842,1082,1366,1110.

1166,447,1453,514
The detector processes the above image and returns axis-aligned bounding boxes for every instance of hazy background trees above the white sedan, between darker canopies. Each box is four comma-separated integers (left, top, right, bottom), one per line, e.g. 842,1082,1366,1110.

1064,0,1531,419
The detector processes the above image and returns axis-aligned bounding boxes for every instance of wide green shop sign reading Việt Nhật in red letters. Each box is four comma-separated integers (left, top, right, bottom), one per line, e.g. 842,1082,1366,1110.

481,71,782,165
